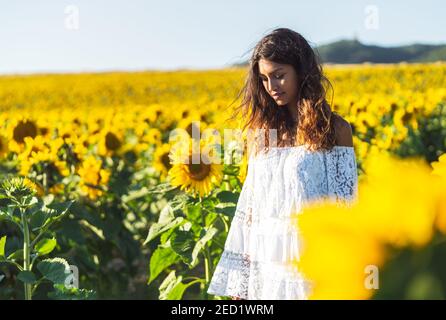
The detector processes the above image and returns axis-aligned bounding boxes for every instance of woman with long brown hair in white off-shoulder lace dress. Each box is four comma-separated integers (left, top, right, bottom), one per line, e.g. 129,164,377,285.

208,28,357,299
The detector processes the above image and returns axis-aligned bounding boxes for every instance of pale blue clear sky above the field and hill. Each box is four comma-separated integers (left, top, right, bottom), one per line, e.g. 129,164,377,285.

0,0,446,74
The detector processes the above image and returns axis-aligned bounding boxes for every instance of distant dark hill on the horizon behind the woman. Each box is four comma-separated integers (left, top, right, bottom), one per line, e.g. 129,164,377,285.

236,40,446,66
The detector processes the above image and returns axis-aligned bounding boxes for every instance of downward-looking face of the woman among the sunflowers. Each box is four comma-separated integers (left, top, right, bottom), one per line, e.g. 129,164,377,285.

259,59,298,106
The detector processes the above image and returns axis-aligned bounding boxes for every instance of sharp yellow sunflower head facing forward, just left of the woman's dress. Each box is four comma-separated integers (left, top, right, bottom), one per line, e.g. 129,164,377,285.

168,139,223,197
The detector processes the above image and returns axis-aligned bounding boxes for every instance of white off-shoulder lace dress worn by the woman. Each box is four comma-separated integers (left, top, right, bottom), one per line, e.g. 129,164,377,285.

207,146,358,300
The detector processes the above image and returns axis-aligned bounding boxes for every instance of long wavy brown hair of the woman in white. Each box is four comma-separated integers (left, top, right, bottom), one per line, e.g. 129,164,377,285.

232,28,340,156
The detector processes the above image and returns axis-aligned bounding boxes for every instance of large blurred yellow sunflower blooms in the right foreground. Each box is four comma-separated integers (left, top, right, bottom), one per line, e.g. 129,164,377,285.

294,154,446,299
